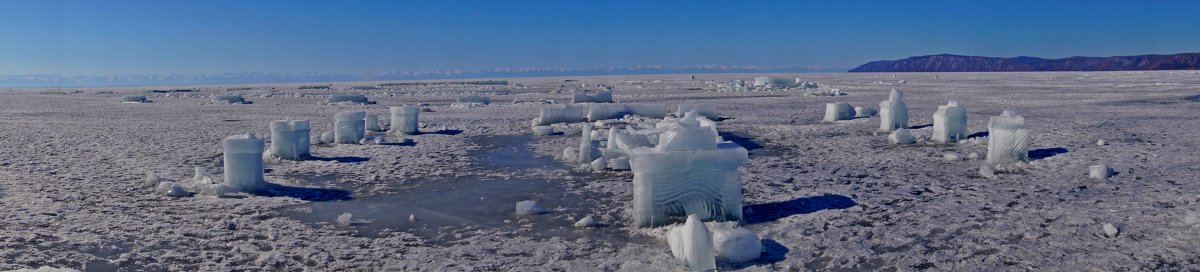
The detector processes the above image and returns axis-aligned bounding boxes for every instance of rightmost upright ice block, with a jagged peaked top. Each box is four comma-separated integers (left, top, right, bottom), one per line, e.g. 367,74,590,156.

988,110,1030,164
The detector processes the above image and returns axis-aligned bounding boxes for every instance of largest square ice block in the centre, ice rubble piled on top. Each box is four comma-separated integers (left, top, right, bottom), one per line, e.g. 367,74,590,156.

628,111,748,226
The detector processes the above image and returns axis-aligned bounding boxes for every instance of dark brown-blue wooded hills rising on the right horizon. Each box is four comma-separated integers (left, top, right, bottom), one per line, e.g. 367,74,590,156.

850,53,1200,73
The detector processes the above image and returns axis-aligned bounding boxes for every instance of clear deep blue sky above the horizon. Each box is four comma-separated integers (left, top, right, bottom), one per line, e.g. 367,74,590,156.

0,0,1200,75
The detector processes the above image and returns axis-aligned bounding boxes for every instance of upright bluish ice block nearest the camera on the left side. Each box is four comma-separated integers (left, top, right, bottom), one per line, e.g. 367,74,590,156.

222,133,269,193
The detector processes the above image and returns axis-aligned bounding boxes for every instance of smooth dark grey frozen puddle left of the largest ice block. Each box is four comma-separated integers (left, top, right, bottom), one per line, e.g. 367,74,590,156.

281,135,628,243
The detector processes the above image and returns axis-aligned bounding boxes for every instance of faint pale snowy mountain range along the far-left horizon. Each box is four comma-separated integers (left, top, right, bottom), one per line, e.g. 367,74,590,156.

0,65,845,87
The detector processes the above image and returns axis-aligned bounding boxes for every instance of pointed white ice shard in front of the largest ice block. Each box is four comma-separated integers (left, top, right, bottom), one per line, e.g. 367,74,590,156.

667,214,716,271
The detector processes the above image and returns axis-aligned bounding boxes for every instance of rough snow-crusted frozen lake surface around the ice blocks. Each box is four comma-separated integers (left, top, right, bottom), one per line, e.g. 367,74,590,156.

0,71,1200,271
